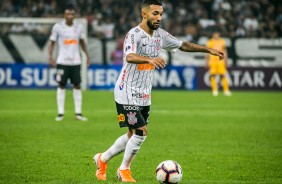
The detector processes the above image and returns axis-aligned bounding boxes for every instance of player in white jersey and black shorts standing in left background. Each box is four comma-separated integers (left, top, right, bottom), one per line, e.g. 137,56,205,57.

49,6,90,121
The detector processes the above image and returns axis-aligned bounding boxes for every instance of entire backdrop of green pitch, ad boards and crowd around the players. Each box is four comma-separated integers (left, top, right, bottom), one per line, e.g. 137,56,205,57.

0,0,282,184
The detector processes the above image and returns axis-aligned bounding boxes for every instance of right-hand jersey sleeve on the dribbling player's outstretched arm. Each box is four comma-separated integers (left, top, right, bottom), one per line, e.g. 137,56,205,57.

162,31,182,52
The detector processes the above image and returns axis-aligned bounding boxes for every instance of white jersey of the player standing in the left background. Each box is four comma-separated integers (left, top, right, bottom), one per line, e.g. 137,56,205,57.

50,21,84,65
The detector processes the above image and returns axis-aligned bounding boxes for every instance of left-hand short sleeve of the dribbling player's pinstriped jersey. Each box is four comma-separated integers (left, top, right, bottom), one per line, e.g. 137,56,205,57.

123,32,137,56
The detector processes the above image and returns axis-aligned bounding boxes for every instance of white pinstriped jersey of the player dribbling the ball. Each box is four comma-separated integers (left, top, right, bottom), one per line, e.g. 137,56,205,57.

114,26,182,106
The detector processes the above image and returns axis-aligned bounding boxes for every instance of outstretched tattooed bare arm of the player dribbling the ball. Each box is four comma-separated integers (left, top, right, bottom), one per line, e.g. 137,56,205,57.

179,42,225,60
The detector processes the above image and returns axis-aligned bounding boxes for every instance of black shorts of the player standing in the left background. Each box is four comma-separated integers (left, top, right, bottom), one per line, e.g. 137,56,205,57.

56,64,81,86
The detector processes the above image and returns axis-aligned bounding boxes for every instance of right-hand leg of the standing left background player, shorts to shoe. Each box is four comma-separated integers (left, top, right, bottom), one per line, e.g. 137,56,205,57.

70,65,87,121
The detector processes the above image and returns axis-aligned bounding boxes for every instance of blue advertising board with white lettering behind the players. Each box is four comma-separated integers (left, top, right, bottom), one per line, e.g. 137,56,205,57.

0,64,197,90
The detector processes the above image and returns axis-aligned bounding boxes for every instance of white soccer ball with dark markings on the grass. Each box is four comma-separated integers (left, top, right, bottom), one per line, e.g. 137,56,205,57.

156,160,182,183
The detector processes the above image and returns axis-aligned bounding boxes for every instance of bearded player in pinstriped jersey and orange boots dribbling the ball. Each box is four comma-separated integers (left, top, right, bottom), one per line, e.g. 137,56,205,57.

93,0,224,182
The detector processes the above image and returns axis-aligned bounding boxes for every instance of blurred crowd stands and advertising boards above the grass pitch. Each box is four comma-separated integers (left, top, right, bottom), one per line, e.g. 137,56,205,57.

0,0,282,90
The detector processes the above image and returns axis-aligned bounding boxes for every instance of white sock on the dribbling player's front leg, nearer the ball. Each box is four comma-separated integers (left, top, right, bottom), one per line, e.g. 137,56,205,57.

119,134,147,170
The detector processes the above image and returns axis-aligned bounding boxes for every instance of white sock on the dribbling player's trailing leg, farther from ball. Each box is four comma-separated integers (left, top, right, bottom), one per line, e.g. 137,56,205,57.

101,133,129,162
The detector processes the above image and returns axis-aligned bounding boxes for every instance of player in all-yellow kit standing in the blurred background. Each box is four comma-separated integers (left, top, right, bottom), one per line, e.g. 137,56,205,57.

206,32,231,96
